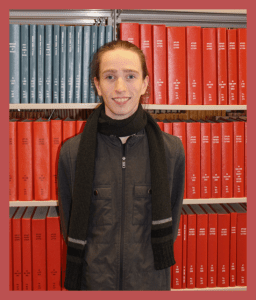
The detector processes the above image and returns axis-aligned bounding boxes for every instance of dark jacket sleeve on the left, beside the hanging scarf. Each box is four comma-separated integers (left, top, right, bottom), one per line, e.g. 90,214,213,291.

58,143,72,244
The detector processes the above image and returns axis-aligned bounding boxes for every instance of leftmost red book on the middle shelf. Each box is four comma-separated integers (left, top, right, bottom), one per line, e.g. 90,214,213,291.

9,119,18,201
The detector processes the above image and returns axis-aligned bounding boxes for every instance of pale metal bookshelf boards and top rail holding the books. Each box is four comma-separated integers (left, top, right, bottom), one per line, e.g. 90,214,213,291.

9,9,247,291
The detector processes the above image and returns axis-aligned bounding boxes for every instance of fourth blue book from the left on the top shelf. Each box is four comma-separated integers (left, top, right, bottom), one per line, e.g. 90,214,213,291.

36,25,44,103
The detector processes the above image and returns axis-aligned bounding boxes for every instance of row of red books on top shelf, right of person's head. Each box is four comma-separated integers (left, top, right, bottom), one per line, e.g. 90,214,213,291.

120,23,247,105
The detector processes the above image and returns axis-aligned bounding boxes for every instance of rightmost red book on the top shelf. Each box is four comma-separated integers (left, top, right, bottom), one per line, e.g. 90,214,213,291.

237,28,247,105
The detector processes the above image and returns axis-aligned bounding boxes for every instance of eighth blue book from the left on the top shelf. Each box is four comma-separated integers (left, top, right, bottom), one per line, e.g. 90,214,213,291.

67,26,75,103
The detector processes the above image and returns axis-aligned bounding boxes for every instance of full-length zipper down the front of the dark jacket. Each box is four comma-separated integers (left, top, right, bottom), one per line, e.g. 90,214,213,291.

119,136,131,290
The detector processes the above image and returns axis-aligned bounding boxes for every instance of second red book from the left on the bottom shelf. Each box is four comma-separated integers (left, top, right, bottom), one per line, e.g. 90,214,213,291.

21,206,35,291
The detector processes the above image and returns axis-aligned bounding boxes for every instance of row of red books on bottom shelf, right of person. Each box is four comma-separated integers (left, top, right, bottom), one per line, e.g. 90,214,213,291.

171,203,247,289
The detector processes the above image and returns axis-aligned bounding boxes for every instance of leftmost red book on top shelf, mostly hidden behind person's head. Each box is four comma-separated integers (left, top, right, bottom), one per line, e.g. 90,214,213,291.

119,23,140,48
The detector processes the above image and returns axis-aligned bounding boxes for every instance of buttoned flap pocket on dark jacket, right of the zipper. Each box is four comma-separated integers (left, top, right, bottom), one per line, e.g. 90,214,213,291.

132,185,152,225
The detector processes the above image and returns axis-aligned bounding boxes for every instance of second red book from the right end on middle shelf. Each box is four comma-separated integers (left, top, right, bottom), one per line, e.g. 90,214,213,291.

221,122,234,198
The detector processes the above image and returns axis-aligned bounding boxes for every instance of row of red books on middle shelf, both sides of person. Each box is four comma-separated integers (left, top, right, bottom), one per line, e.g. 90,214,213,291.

9,119,247,201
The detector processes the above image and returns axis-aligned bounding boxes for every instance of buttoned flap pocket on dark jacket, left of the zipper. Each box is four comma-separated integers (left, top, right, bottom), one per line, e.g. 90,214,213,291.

92,185,113,226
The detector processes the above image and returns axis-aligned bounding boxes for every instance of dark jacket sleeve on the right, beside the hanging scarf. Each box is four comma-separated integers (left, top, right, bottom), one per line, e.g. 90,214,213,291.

171,137,185,241
